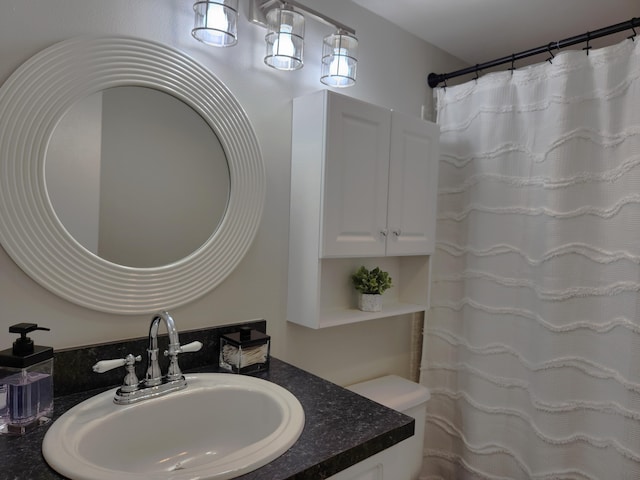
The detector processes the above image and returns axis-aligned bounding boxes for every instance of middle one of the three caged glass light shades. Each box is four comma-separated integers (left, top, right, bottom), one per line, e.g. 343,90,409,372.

264,7,304,70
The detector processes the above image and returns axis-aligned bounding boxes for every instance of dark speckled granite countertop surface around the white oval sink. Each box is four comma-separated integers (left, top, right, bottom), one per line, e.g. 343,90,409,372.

0,358,414,480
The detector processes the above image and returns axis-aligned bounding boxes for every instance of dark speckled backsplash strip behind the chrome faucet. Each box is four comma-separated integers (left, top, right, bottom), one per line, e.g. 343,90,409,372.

53,320,267,397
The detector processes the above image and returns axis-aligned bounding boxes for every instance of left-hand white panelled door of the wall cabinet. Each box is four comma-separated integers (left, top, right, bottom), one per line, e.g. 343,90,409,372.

321,95,391,257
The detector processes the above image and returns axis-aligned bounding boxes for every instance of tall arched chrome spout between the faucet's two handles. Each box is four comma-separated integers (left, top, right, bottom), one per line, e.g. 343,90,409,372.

144,311,182,387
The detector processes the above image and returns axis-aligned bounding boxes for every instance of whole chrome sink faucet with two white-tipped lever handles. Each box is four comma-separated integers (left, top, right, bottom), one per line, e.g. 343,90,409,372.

93,311,202,405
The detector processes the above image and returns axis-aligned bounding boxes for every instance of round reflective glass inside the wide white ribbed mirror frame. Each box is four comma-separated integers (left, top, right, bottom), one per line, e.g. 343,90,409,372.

44,86,230,268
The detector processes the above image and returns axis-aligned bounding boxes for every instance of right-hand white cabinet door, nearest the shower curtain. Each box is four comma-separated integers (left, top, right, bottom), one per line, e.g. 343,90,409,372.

386,112,440,255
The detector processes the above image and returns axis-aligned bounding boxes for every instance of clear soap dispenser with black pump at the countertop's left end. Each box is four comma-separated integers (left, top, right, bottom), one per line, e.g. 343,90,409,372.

0,323,53,435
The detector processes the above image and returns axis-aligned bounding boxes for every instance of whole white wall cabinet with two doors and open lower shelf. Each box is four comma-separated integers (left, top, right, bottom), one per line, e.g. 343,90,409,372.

287,90,439,328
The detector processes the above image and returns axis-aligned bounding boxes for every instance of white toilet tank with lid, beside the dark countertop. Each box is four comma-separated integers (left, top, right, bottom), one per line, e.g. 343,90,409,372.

346,375,431,480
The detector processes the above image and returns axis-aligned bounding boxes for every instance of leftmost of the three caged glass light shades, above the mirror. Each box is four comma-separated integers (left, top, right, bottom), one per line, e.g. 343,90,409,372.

191,0,238,47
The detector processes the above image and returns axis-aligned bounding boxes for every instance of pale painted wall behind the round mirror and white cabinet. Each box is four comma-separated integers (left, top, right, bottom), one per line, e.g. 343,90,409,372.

0,0,462,384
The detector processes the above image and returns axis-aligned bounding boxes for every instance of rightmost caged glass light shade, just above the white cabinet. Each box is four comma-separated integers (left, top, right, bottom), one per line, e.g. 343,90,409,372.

320,31,358,88
